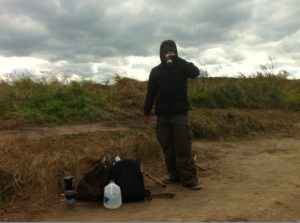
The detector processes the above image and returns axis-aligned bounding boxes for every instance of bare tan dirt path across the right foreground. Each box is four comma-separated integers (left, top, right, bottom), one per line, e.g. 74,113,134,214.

31,134,300,221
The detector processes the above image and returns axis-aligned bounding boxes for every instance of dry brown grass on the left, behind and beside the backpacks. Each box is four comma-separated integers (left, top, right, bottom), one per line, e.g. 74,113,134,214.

0,131,161,213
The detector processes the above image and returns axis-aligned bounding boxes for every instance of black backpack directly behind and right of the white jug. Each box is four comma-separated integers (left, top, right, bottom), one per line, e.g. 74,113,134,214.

110,159,151,202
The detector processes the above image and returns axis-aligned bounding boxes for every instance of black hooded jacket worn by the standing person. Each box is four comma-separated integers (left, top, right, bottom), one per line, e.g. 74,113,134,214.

144,40,199,116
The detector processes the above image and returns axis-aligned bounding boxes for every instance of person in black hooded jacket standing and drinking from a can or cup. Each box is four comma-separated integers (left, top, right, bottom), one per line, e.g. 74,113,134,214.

144,40,201,190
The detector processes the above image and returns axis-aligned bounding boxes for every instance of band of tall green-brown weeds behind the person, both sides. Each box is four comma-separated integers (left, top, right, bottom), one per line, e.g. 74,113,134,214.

0,72,300,124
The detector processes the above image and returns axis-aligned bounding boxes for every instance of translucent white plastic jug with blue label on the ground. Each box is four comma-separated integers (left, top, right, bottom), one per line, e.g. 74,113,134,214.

103,180,122,209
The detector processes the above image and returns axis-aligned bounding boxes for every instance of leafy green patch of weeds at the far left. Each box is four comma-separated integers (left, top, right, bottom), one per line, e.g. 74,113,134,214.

0,78,108,124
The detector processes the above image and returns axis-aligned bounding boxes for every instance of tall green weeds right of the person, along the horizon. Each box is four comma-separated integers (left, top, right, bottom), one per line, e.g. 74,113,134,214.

189,75,300,110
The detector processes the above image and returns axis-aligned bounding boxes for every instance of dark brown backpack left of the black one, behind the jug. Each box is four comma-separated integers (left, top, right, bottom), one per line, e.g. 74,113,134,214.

75,155,112,201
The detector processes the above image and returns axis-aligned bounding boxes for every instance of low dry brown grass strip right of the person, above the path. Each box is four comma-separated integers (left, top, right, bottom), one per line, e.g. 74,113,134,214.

190,108,300,139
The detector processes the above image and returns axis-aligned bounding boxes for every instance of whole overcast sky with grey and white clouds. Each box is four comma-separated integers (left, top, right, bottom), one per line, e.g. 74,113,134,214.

0,0,300,82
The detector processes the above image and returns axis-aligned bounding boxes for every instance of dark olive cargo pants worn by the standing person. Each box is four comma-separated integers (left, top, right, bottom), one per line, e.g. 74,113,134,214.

156,114,198,185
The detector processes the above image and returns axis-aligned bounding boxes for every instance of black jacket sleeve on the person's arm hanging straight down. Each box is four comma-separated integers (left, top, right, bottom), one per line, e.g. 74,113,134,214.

144,69,156,116
